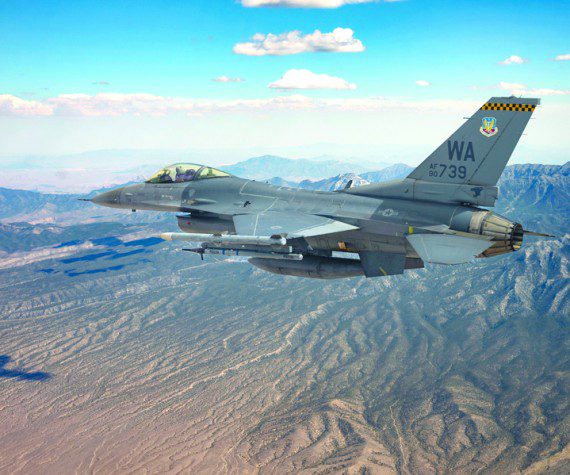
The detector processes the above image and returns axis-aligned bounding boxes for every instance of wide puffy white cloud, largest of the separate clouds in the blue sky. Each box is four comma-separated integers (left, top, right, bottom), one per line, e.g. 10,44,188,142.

233,28,364,56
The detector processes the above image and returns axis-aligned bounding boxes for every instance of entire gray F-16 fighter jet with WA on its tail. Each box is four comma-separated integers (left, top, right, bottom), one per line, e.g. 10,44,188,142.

91,97,552,279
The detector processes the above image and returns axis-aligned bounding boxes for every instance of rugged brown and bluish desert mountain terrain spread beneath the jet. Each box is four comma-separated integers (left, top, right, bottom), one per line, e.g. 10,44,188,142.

0,164,570,474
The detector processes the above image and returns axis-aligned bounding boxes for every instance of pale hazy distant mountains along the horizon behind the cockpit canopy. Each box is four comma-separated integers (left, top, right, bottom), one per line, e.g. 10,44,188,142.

0,155,386,194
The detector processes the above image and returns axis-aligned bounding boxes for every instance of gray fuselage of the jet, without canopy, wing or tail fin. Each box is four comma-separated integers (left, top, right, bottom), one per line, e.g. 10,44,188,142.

93,177,481,257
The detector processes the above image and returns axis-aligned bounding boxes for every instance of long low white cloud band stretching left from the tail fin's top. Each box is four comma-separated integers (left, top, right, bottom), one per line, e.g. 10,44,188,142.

0,93,478,117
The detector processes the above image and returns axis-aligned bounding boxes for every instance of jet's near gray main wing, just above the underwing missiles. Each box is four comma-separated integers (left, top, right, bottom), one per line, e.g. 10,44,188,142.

233,211,358,239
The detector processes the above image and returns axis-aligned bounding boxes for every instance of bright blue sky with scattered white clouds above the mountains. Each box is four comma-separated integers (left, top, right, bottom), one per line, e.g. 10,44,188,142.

0,0,570,166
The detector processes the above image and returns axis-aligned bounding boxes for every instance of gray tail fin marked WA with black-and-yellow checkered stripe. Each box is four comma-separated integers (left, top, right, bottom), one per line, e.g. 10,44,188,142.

408,97,540,186
